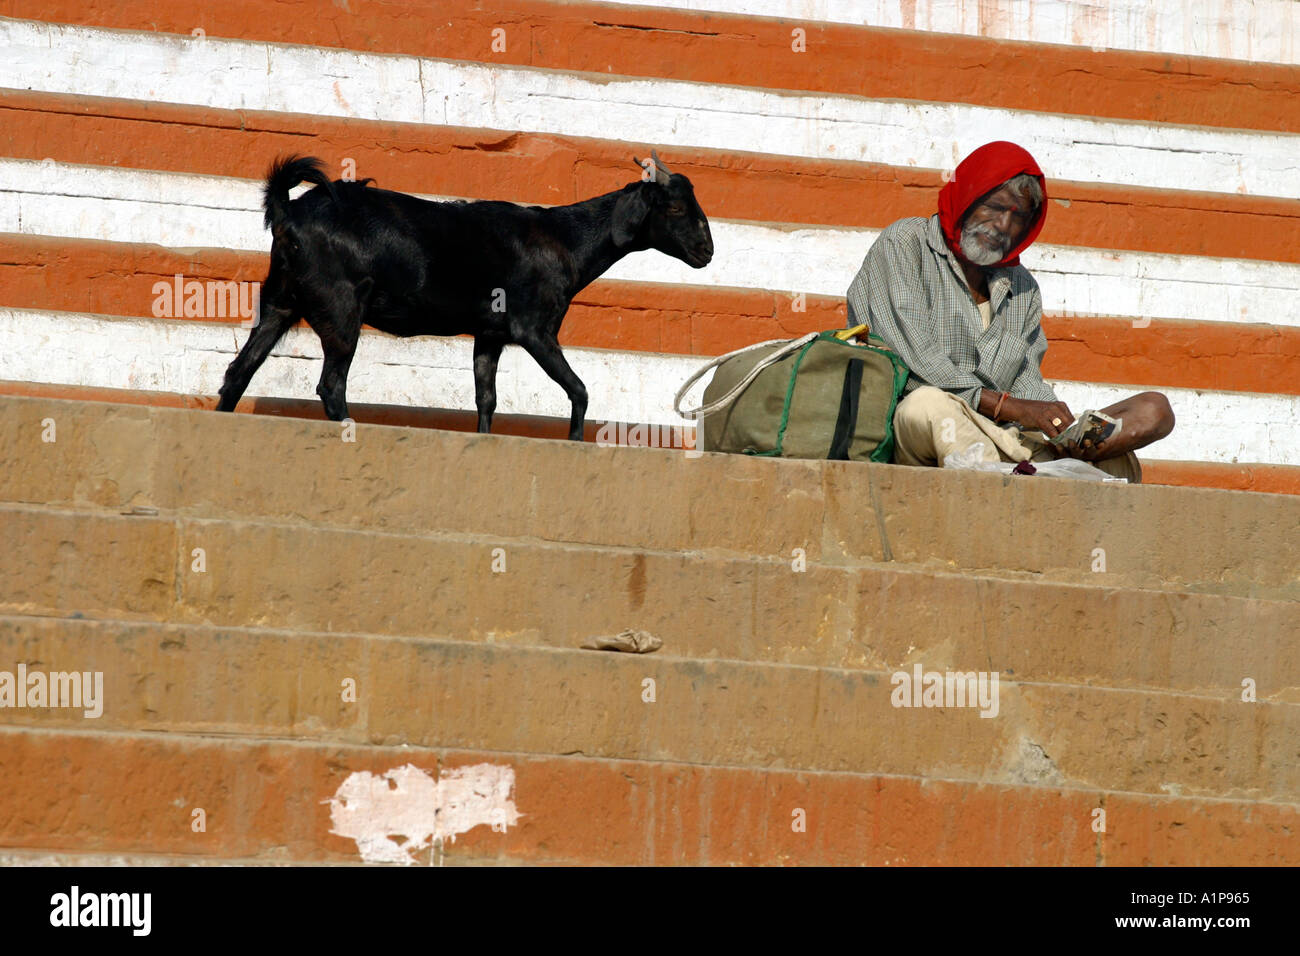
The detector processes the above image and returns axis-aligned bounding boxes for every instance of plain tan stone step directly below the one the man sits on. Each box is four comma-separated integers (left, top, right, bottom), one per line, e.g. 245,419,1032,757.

0,505,1300,702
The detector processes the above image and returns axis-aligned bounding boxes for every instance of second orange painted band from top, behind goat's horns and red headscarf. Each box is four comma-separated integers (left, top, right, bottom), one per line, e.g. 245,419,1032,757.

0,91,1300,264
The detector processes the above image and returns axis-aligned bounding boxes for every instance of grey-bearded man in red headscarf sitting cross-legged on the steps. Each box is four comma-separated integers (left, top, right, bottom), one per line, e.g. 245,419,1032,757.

848,142,1174,481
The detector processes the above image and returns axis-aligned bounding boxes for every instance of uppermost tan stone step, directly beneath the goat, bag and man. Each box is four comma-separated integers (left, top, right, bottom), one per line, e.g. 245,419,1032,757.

0,397,1300,600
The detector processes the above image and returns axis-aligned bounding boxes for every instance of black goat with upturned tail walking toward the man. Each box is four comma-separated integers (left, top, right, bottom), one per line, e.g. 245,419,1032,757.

217,151,714,441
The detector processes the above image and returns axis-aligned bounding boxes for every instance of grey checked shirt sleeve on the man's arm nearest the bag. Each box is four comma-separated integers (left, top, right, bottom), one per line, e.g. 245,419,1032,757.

845,230,983,408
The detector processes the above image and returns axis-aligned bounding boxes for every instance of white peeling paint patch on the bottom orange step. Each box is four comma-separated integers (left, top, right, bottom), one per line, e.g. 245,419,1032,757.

322,763,521,866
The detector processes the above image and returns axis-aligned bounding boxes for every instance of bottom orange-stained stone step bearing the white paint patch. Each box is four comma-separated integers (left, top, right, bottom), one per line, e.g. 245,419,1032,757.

0,728,1300,866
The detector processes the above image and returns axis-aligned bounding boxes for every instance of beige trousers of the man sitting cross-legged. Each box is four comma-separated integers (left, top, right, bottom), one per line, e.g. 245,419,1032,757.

894,385,1141,484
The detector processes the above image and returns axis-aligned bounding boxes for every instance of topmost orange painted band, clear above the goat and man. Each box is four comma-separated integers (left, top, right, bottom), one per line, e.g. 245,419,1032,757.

0,0,1300,133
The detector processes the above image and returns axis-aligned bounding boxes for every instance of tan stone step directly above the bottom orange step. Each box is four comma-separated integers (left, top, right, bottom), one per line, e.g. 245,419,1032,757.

0,618,1300,805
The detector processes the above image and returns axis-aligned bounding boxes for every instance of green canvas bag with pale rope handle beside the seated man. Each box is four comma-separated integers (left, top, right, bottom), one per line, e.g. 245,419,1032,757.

675,325,909,462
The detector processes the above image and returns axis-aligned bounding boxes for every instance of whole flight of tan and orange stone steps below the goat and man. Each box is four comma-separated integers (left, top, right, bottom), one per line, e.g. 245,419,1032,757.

0,397,1300,866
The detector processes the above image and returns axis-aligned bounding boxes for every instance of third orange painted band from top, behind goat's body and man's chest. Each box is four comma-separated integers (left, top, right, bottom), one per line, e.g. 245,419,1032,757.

0,234,1300,395
